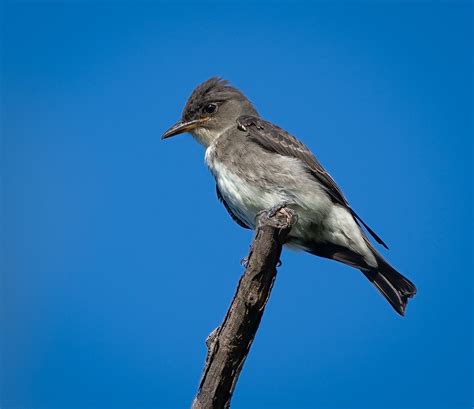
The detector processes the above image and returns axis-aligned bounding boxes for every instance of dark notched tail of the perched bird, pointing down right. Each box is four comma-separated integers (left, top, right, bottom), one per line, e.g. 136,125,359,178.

361,252,416,315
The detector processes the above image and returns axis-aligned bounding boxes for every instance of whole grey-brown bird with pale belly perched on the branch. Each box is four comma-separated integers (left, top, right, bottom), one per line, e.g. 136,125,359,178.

162,78,416,315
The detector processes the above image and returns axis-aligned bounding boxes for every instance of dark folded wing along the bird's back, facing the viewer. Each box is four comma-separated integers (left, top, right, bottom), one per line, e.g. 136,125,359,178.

237,115,388,249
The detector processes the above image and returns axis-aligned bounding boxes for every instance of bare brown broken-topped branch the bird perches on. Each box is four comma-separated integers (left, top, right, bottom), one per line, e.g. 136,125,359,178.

192,207,296,409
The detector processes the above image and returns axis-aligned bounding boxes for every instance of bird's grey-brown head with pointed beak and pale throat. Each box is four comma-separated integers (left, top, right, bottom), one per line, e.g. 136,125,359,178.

162,77,257,147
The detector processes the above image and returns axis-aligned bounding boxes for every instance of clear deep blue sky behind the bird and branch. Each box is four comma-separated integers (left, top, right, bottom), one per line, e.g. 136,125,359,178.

1,1,474,409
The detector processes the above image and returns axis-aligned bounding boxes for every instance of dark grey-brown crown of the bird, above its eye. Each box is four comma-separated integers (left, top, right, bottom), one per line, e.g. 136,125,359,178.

183,77,247,121
